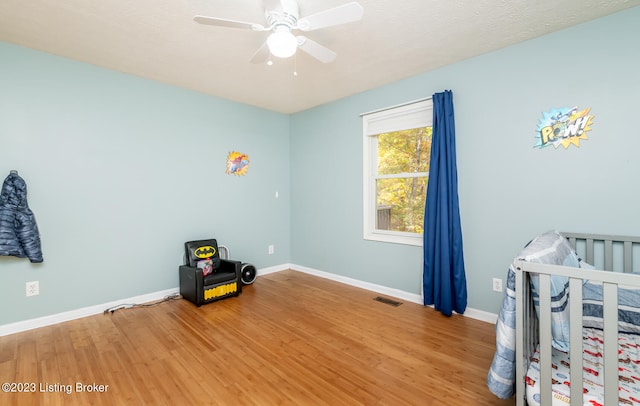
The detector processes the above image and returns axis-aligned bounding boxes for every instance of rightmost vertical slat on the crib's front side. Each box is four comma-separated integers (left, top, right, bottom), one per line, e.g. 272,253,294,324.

602,282,619,405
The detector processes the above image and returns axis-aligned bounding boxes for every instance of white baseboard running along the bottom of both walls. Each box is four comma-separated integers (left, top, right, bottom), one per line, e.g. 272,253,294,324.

0,264,498,337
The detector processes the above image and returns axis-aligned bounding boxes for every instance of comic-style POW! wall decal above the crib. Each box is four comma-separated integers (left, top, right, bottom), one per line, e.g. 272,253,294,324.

533,107,593,149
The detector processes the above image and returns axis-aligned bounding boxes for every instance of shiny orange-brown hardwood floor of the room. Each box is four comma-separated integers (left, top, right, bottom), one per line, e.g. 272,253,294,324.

0,271,515,405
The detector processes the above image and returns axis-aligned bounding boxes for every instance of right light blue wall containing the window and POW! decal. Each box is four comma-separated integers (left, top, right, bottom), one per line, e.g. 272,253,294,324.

291,7,640,313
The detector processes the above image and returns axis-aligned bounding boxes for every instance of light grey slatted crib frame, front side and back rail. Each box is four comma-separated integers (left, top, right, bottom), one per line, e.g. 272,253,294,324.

515,233,640,406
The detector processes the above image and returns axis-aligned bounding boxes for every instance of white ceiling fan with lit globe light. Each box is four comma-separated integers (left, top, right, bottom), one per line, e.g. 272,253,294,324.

193,0,364,63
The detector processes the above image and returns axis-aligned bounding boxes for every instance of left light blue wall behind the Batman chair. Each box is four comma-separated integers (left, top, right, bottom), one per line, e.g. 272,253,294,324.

0,43,290,325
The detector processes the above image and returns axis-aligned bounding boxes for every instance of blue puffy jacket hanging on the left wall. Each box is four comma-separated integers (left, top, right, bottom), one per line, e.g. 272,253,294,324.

0,172,42,262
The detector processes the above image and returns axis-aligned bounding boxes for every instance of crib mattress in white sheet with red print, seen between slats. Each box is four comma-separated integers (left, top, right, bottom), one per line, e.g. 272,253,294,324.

525,328,640,406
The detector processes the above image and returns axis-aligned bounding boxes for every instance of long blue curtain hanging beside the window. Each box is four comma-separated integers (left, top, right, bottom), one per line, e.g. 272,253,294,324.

422,90,467,316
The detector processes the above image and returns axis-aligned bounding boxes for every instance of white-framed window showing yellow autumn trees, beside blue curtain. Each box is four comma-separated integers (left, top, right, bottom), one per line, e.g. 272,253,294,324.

362,99,433,245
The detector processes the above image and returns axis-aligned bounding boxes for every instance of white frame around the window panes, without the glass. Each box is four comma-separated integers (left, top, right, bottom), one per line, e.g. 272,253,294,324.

362,98,433,246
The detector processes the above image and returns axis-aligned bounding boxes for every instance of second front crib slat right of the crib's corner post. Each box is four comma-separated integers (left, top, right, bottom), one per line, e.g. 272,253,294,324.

569,278,583,405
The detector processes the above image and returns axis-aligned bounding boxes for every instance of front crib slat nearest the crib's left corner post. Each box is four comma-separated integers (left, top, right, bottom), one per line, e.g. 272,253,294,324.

538,274,551,405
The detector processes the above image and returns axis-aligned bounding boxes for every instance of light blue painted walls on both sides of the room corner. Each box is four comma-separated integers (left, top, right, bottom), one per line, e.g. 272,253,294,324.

0,7,640,325
